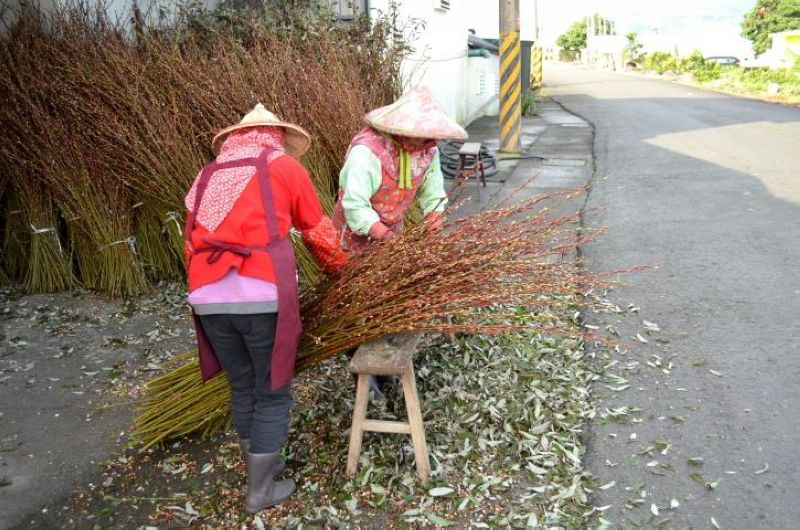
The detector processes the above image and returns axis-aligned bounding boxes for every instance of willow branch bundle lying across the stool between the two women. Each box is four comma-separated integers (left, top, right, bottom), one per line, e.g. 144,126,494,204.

132,193,606,447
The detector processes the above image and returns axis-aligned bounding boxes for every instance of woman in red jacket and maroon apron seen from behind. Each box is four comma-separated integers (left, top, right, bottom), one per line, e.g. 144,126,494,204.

185,103,347,513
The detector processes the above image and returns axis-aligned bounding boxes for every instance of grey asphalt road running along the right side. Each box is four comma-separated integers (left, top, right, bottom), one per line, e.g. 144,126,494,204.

545,65,800,529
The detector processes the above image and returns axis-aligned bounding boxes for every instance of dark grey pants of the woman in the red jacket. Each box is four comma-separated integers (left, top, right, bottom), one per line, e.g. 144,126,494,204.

200,313,292,453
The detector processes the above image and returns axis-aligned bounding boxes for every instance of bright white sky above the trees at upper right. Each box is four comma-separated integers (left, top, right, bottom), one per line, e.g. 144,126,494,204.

536,0,756,57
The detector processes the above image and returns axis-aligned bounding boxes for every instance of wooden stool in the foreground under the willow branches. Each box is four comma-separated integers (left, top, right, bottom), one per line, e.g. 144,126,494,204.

347,335,431,480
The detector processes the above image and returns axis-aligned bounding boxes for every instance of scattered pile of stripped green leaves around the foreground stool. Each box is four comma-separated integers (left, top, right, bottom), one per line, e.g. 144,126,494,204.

111,295,602,528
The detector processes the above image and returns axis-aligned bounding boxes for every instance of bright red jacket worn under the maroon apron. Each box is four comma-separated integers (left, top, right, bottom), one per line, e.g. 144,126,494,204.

186,155,347,292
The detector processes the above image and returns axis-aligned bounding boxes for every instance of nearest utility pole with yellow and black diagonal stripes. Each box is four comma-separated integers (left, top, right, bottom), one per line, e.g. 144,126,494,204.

500,0,522,153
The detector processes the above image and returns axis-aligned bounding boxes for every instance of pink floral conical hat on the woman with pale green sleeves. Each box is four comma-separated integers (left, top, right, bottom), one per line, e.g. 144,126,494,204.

364,87,468,140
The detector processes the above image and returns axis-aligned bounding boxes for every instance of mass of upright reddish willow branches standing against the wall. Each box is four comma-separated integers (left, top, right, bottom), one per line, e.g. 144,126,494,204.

0,0,404,296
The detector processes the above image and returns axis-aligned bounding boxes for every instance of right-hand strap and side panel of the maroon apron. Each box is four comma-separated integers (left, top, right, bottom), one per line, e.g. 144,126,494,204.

256,151,302,390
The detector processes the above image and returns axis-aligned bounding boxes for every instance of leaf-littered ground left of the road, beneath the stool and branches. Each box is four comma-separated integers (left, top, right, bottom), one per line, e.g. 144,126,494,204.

0,286,596,530
